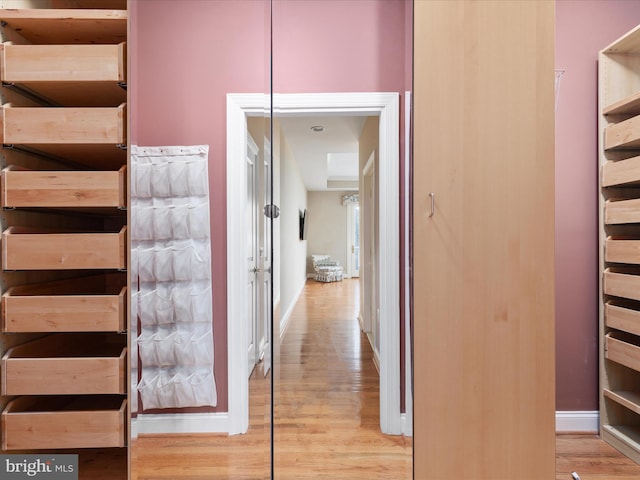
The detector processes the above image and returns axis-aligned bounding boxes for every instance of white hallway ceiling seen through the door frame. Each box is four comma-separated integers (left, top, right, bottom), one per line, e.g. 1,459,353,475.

278,116,367,191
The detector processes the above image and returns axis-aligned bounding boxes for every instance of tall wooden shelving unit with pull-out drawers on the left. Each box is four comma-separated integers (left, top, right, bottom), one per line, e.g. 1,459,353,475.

0,0,129,480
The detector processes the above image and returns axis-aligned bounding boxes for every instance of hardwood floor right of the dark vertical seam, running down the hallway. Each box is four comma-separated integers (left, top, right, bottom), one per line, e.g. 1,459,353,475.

274,279,412,480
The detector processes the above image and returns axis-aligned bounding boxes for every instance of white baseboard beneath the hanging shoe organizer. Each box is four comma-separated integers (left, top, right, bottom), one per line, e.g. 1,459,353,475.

131,412,229,438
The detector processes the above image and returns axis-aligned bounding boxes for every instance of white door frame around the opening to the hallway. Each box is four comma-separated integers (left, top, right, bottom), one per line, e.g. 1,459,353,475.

227,93,402,434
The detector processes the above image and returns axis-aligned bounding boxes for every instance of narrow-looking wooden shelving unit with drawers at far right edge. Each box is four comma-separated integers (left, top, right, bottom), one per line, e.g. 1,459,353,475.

599,22,640,463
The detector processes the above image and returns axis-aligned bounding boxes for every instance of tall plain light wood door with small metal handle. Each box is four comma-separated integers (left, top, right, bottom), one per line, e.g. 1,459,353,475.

413,0,555,480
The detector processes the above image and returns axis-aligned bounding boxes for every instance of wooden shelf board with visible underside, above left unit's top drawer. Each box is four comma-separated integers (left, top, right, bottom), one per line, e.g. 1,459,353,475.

0,9,127,44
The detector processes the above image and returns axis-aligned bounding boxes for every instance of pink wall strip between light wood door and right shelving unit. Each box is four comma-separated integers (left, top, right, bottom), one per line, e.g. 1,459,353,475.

556,0,640,410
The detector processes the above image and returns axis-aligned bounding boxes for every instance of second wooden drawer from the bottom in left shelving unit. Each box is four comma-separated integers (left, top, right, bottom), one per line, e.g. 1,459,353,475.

1,334,127,395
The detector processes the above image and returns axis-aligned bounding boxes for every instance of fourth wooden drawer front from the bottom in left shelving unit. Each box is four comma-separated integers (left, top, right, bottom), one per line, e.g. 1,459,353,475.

2,227,126,270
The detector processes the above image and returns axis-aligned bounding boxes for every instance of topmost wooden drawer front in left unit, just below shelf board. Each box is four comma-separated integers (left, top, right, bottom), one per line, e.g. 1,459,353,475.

2,43,126,83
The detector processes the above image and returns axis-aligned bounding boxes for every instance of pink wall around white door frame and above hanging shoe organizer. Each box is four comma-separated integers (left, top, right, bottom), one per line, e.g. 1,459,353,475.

129,0,407,411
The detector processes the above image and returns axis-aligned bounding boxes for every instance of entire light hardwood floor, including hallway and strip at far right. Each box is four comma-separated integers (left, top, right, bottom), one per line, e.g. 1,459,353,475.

131,280,640,480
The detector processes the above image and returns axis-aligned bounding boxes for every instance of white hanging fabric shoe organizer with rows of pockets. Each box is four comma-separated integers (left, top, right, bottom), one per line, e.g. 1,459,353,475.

131,145,217,410
